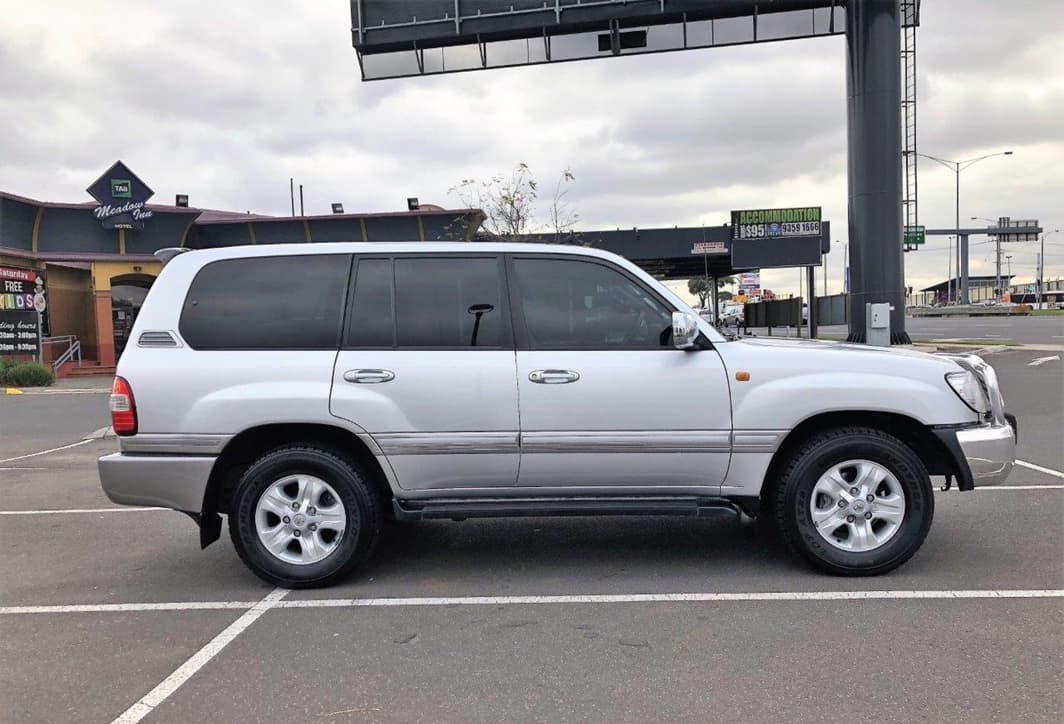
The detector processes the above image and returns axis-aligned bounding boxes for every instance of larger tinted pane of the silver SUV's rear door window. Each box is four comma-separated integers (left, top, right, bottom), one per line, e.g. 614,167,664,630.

395,257,506,347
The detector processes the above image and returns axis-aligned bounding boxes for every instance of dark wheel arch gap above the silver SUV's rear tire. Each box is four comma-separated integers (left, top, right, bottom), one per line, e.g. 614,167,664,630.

200,423,393,548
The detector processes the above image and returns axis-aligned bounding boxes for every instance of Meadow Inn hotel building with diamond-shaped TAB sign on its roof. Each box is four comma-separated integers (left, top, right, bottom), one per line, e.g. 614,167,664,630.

0,161,483,376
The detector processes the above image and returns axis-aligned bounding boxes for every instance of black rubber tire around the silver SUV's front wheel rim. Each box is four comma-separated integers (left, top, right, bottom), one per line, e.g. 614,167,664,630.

767,427,934,576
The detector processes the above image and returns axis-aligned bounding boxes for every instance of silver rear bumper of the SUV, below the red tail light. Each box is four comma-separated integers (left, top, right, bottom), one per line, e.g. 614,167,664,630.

97,453,216,515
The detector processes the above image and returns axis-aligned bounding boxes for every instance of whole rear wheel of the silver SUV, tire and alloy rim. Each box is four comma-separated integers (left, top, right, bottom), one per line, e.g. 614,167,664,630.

229,445,382,588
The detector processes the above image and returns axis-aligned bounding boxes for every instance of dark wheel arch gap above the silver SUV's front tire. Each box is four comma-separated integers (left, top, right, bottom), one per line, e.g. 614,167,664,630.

759,410,963,515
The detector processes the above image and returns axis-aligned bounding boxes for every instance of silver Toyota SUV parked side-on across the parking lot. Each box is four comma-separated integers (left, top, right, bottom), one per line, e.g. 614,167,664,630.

99,243,1015,588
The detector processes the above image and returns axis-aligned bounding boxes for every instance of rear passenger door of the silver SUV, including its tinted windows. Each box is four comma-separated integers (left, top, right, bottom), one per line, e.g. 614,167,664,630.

332,254,519,490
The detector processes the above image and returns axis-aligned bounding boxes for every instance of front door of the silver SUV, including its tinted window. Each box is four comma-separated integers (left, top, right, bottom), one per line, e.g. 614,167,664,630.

509,256,731,488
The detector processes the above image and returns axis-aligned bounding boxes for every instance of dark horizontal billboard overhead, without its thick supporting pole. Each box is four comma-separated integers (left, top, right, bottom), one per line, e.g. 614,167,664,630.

350,0,845,81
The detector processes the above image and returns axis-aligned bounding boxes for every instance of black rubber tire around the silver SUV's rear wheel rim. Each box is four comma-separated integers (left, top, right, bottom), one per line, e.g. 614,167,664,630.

229,445,383,589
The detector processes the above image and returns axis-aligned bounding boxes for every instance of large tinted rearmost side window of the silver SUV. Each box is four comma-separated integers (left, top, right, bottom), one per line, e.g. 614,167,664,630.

180,254,351,349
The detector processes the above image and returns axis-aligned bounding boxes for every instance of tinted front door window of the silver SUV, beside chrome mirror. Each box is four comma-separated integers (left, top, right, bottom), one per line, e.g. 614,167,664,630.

514,259,672,349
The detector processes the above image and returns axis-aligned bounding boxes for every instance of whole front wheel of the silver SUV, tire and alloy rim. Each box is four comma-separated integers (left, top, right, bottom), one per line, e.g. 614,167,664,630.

774,427,934,576
